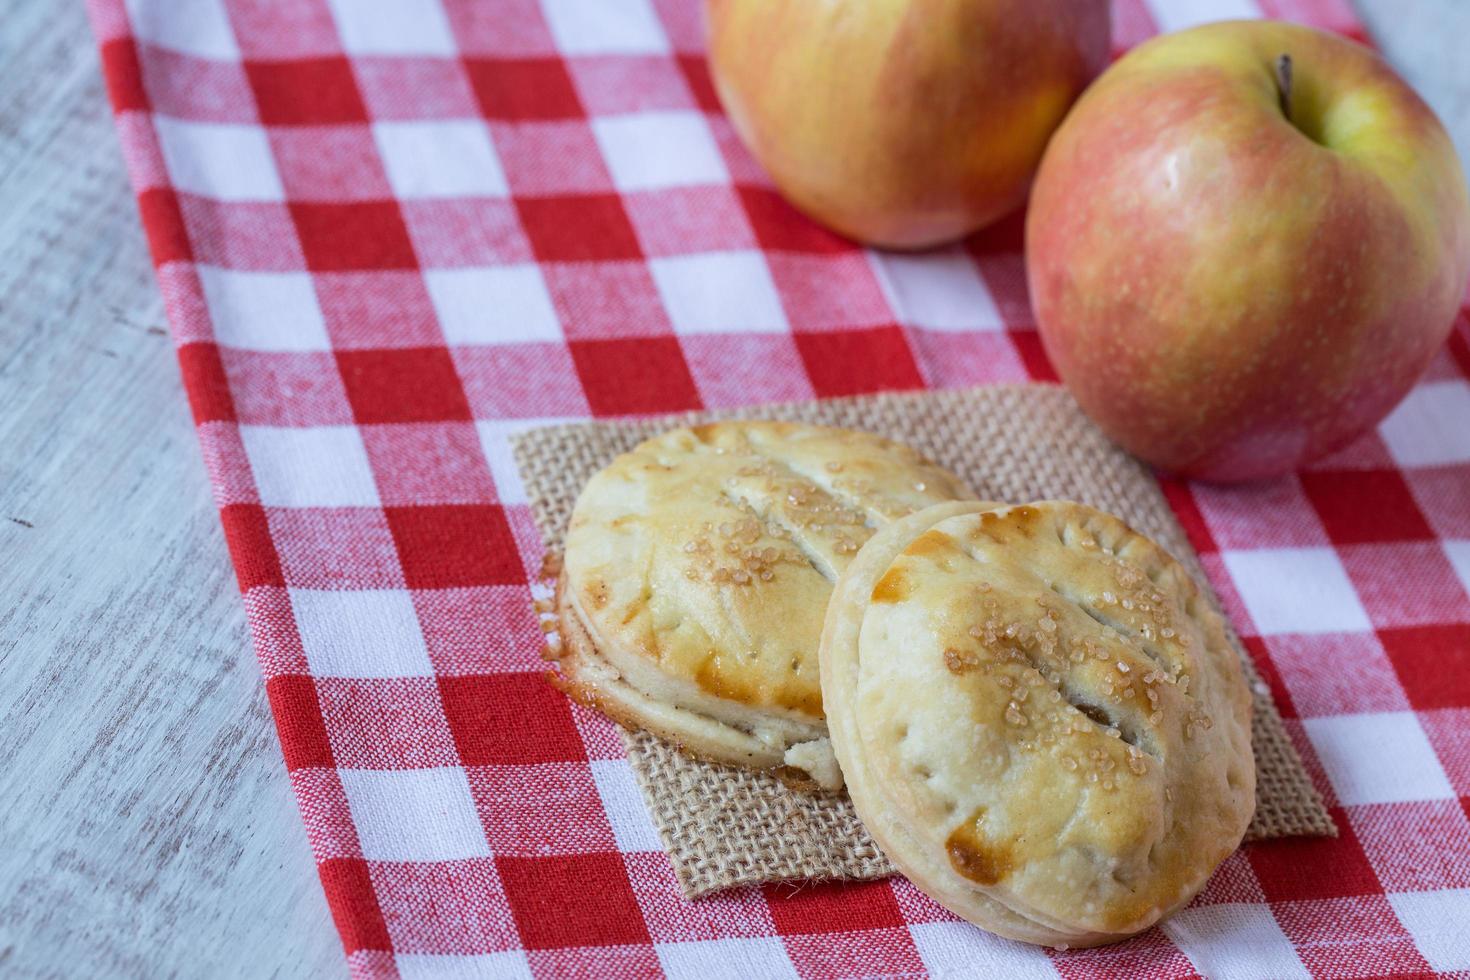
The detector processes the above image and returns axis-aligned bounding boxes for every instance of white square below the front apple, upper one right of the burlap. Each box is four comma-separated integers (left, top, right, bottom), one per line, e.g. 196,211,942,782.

1223,548,1373,633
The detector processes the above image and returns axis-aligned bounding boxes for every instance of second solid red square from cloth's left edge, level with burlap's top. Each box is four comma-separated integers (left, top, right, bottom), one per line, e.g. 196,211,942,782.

337,347,469,425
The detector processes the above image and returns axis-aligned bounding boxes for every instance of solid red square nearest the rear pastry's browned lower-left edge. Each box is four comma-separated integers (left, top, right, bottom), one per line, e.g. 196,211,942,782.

440,673,587,765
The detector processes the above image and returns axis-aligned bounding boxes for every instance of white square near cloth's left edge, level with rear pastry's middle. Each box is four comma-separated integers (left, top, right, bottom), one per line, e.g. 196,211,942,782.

291,589,434,677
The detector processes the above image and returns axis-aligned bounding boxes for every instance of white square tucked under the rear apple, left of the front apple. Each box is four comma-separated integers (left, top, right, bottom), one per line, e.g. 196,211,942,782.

869,247,1005,331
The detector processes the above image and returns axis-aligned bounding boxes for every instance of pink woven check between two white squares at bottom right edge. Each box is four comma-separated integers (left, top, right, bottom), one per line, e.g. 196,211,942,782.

1272,895,1436,980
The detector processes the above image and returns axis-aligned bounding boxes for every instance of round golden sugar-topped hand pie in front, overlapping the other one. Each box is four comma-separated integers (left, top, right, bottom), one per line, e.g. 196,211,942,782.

820,501,1255,946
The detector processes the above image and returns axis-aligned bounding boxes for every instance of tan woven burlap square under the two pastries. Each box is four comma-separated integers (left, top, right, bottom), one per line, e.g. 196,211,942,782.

513,385,1336,898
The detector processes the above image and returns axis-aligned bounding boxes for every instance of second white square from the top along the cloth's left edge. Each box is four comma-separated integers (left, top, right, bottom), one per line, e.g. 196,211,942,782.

153,115,285,201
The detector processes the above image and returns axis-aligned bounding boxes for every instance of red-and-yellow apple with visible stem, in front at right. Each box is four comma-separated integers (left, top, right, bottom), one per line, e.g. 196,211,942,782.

1026,21,1470,480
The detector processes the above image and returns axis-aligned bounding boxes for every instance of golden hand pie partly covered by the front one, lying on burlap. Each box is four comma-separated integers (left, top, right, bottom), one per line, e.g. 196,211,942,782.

556,422,975,788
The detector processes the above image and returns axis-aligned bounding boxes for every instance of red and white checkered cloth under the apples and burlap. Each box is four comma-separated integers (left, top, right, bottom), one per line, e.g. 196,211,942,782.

90,0,1470,980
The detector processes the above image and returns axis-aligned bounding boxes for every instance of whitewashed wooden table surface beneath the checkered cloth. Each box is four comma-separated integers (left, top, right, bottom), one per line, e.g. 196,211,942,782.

0,0,1470,977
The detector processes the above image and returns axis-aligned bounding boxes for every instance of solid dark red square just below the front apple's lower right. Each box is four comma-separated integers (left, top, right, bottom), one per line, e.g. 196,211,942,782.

1301,470,1435,545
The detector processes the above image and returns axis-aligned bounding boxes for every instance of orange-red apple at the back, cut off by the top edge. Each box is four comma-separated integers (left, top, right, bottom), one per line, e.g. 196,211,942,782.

704,0,1108,248
